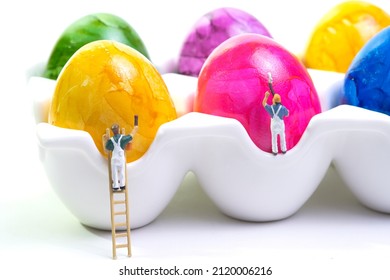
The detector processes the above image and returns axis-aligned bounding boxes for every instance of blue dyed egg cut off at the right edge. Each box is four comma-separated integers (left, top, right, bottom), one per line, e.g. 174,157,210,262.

344,27,390,115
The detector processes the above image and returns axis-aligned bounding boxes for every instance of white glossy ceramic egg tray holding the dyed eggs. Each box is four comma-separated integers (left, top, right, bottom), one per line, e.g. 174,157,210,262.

28,70,390,229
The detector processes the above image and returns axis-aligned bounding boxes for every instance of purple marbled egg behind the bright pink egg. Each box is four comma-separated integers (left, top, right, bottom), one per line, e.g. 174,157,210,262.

178,8,271,76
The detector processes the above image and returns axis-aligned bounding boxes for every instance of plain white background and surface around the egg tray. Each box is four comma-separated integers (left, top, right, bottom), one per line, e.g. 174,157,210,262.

0,0,390,279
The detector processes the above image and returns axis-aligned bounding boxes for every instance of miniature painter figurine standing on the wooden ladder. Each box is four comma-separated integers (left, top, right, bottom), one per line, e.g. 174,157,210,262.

105,123,138,191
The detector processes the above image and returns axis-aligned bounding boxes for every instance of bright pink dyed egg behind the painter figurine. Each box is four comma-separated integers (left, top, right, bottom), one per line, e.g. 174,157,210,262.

194,34,321,152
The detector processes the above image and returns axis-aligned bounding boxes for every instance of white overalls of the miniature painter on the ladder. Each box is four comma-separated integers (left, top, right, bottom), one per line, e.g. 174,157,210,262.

111,135,126,189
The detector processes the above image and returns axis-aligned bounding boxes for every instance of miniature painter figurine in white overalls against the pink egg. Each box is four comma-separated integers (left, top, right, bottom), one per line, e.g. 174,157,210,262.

263,73,289,156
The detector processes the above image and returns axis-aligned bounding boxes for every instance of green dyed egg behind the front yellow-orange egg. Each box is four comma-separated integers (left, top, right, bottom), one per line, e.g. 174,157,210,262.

43,13,149,80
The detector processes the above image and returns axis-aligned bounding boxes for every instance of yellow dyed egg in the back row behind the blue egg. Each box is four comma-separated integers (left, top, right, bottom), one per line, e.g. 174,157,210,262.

303,1,390,73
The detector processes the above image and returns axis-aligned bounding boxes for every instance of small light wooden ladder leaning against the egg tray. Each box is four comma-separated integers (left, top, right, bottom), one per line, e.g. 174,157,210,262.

103,128,131,259
